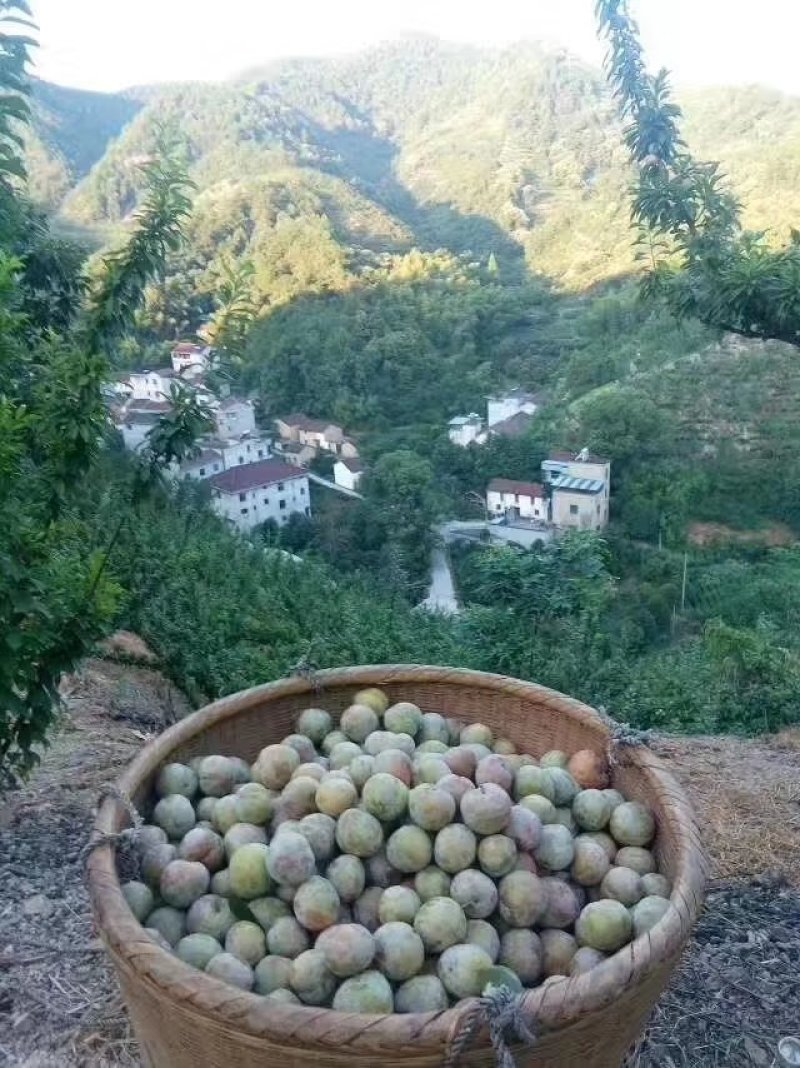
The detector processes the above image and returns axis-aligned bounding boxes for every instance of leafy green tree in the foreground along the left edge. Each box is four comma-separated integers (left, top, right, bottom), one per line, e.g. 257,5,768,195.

0,12,198,783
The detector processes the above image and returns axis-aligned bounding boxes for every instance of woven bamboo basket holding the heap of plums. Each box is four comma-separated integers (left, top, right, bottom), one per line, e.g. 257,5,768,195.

89,665,705,1068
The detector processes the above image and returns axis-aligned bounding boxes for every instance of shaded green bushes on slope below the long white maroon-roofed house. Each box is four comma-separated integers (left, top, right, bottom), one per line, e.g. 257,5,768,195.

74,459,458,701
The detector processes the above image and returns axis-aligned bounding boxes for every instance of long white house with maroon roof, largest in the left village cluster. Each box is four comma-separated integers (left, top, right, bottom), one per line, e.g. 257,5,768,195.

209,459,311,531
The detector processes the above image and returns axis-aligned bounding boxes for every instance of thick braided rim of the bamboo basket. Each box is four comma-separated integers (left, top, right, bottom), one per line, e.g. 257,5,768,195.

87,664,707,1052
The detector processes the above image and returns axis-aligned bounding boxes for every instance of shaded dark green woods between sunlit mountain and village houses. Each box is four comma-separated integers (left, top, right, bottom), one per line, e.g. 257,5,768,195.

242,251,555,427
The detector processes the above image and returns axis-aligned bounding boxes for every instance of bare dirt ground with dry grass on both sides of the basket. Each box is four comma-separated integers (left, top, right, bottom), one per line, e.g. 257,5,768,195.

0,643,800,1068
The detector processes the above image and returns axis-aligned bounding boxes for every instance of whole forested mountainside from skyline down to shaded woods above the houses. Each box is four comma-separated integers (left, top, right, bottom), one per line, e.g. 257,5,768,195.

29,38,800,428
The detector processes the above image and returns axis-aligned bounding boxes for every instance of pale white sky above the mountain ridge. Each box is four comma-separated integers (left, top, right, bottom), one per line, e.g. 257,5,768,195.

32,0,800,95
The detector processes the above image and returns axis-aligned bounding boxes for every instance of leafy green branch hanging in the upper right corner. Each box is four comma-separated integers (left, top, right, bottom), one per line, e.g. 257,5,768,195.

595,0,800,346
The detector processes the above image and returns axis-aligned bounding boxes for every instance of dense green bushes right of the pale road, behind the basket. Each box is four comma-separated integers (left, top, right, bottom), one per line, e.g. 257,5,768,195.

455,534,800,732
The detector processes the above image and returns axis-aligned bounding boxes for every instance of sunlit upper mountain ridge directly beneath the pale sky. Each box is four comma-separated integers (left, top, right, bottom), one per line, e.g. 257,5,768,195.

23,37,800,289
